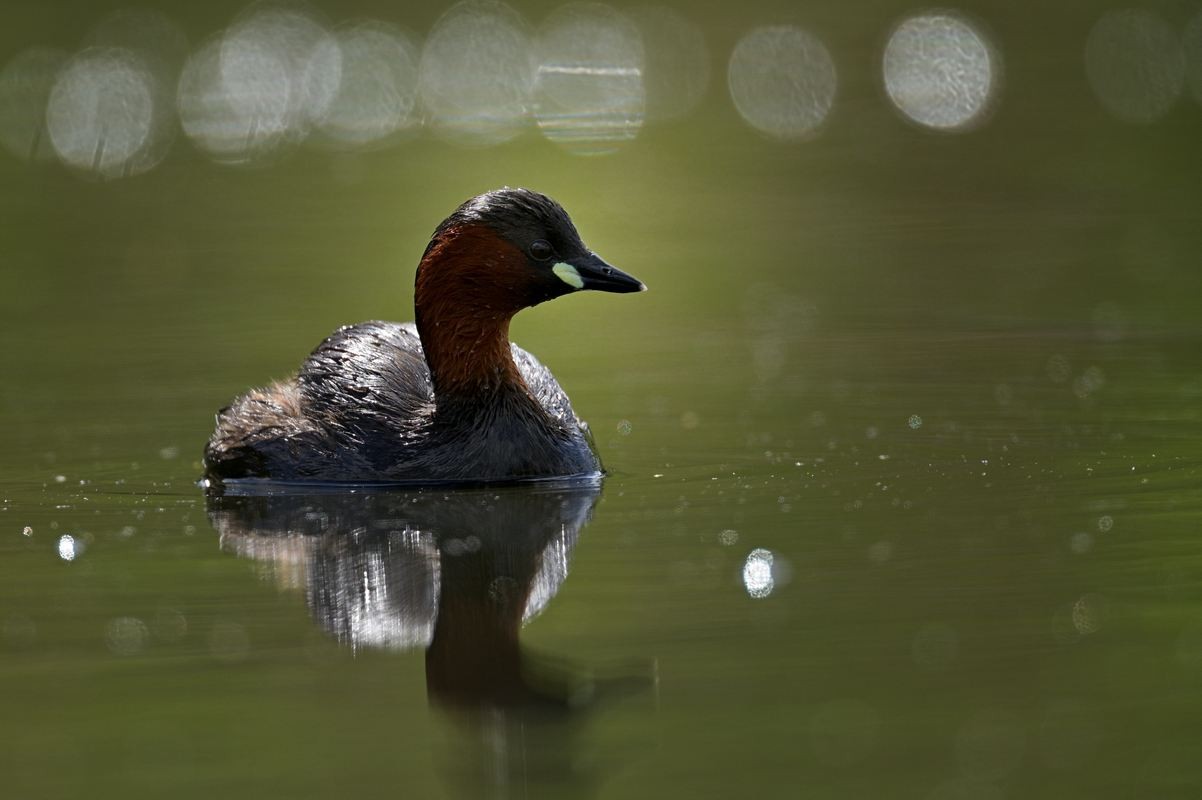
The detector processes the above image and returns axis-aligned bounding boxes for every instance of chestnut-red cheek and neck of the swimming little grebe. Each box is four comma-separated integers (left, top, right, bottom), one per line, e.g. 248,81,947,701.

413,226,529,406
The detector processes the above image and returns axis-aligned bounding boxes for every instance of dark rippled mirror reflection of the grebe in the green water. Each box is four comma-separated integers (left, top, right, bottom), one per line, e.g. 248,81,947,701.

208,482,654,796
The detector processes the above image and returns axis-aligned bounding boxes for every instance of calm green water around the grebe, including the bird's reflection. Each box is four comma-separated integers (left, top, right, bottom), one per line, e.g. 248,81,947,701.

0,4,1202,800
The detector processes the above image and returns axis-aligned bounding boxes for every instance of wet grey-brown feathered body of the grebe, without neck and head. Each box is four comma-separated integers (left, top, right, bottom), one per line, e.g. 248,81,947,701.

204,322,600,482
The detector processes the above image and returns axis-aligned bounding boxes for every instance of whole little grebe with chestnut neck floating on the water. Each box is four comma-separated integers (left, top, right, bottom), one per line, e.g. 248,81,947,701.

204,189,647,483
